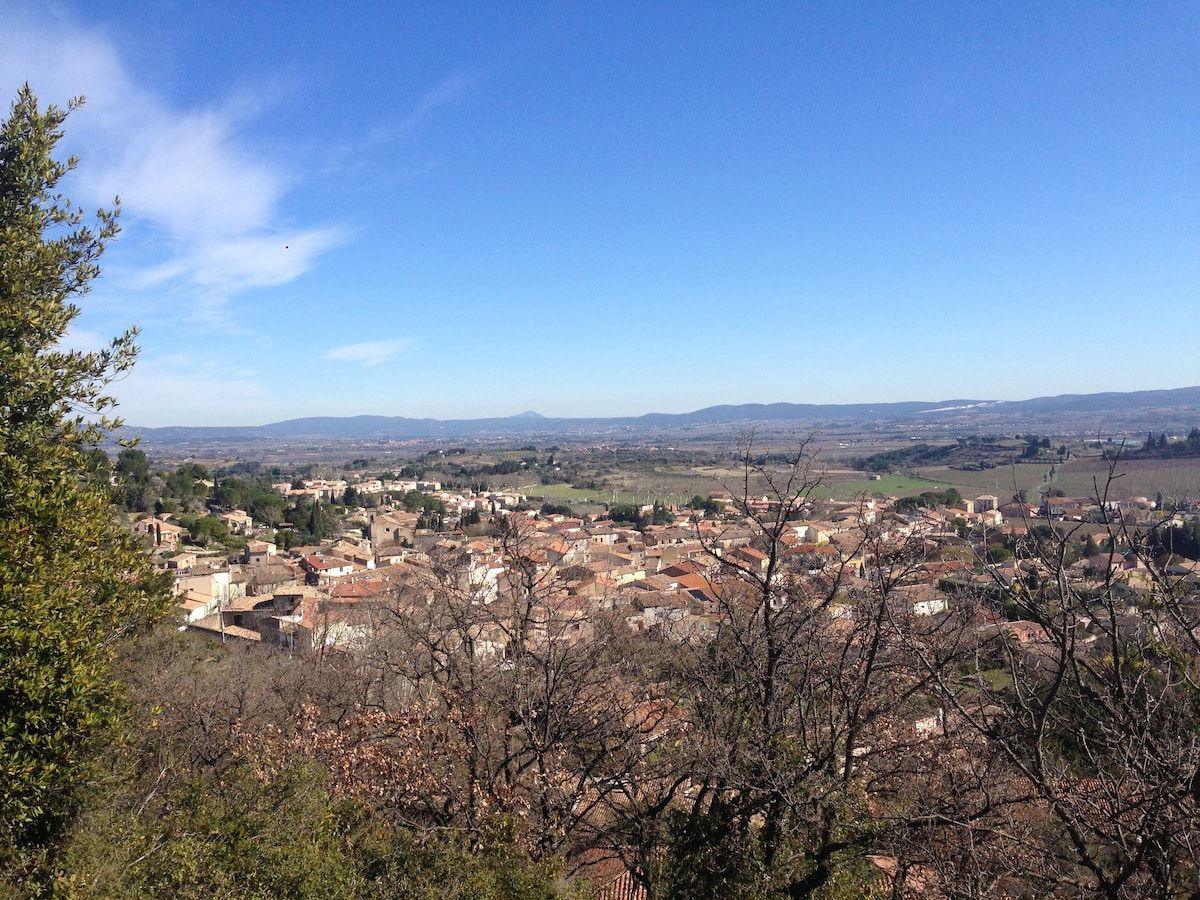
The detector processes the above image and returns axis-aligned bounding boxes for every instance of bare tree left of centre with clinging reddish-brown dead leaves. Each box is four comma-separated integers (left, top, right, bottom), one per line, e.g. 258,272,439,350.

279,526,664,864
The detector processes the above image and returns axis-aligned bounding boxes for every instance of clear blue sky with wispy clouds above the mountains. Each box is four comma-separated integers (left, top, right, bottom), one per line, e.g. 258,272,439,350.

0,0,1200,426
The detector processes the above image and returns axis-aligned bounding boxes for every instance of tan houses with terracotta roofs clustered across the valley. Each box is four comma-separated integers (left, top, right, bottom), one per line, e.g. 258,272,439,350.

133,479,1196,667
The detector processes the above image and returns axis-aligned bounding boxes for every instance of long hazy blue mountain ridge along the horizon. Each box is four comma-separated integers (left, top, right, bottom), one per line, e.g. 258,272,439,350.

125,386,1200,444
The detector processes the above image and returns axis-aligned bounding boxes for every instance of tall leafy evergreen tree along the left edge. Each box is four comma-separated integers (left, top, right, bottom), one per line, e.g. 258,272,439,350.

0,86,166,862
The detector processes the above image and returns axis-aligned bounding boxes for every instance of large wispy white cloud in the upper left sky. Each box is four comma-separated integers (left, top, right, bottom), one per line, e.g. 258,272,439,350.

0,7,348,320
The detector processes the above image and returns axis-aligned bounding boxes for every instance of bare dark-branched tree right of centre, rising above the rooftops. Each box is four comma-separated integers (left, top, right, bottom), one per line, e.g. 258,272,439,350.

665,434,940,896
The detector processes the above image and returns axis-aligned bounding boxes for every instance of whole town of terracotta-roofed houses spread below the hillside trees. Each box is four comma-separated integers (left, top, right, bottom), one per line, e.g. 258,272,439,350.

132,465,1176,654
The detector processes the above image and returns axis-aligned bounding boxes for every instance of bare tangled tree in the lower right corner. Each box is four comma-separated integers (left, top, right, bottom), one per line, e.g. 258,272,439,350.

913,460,1200,898
